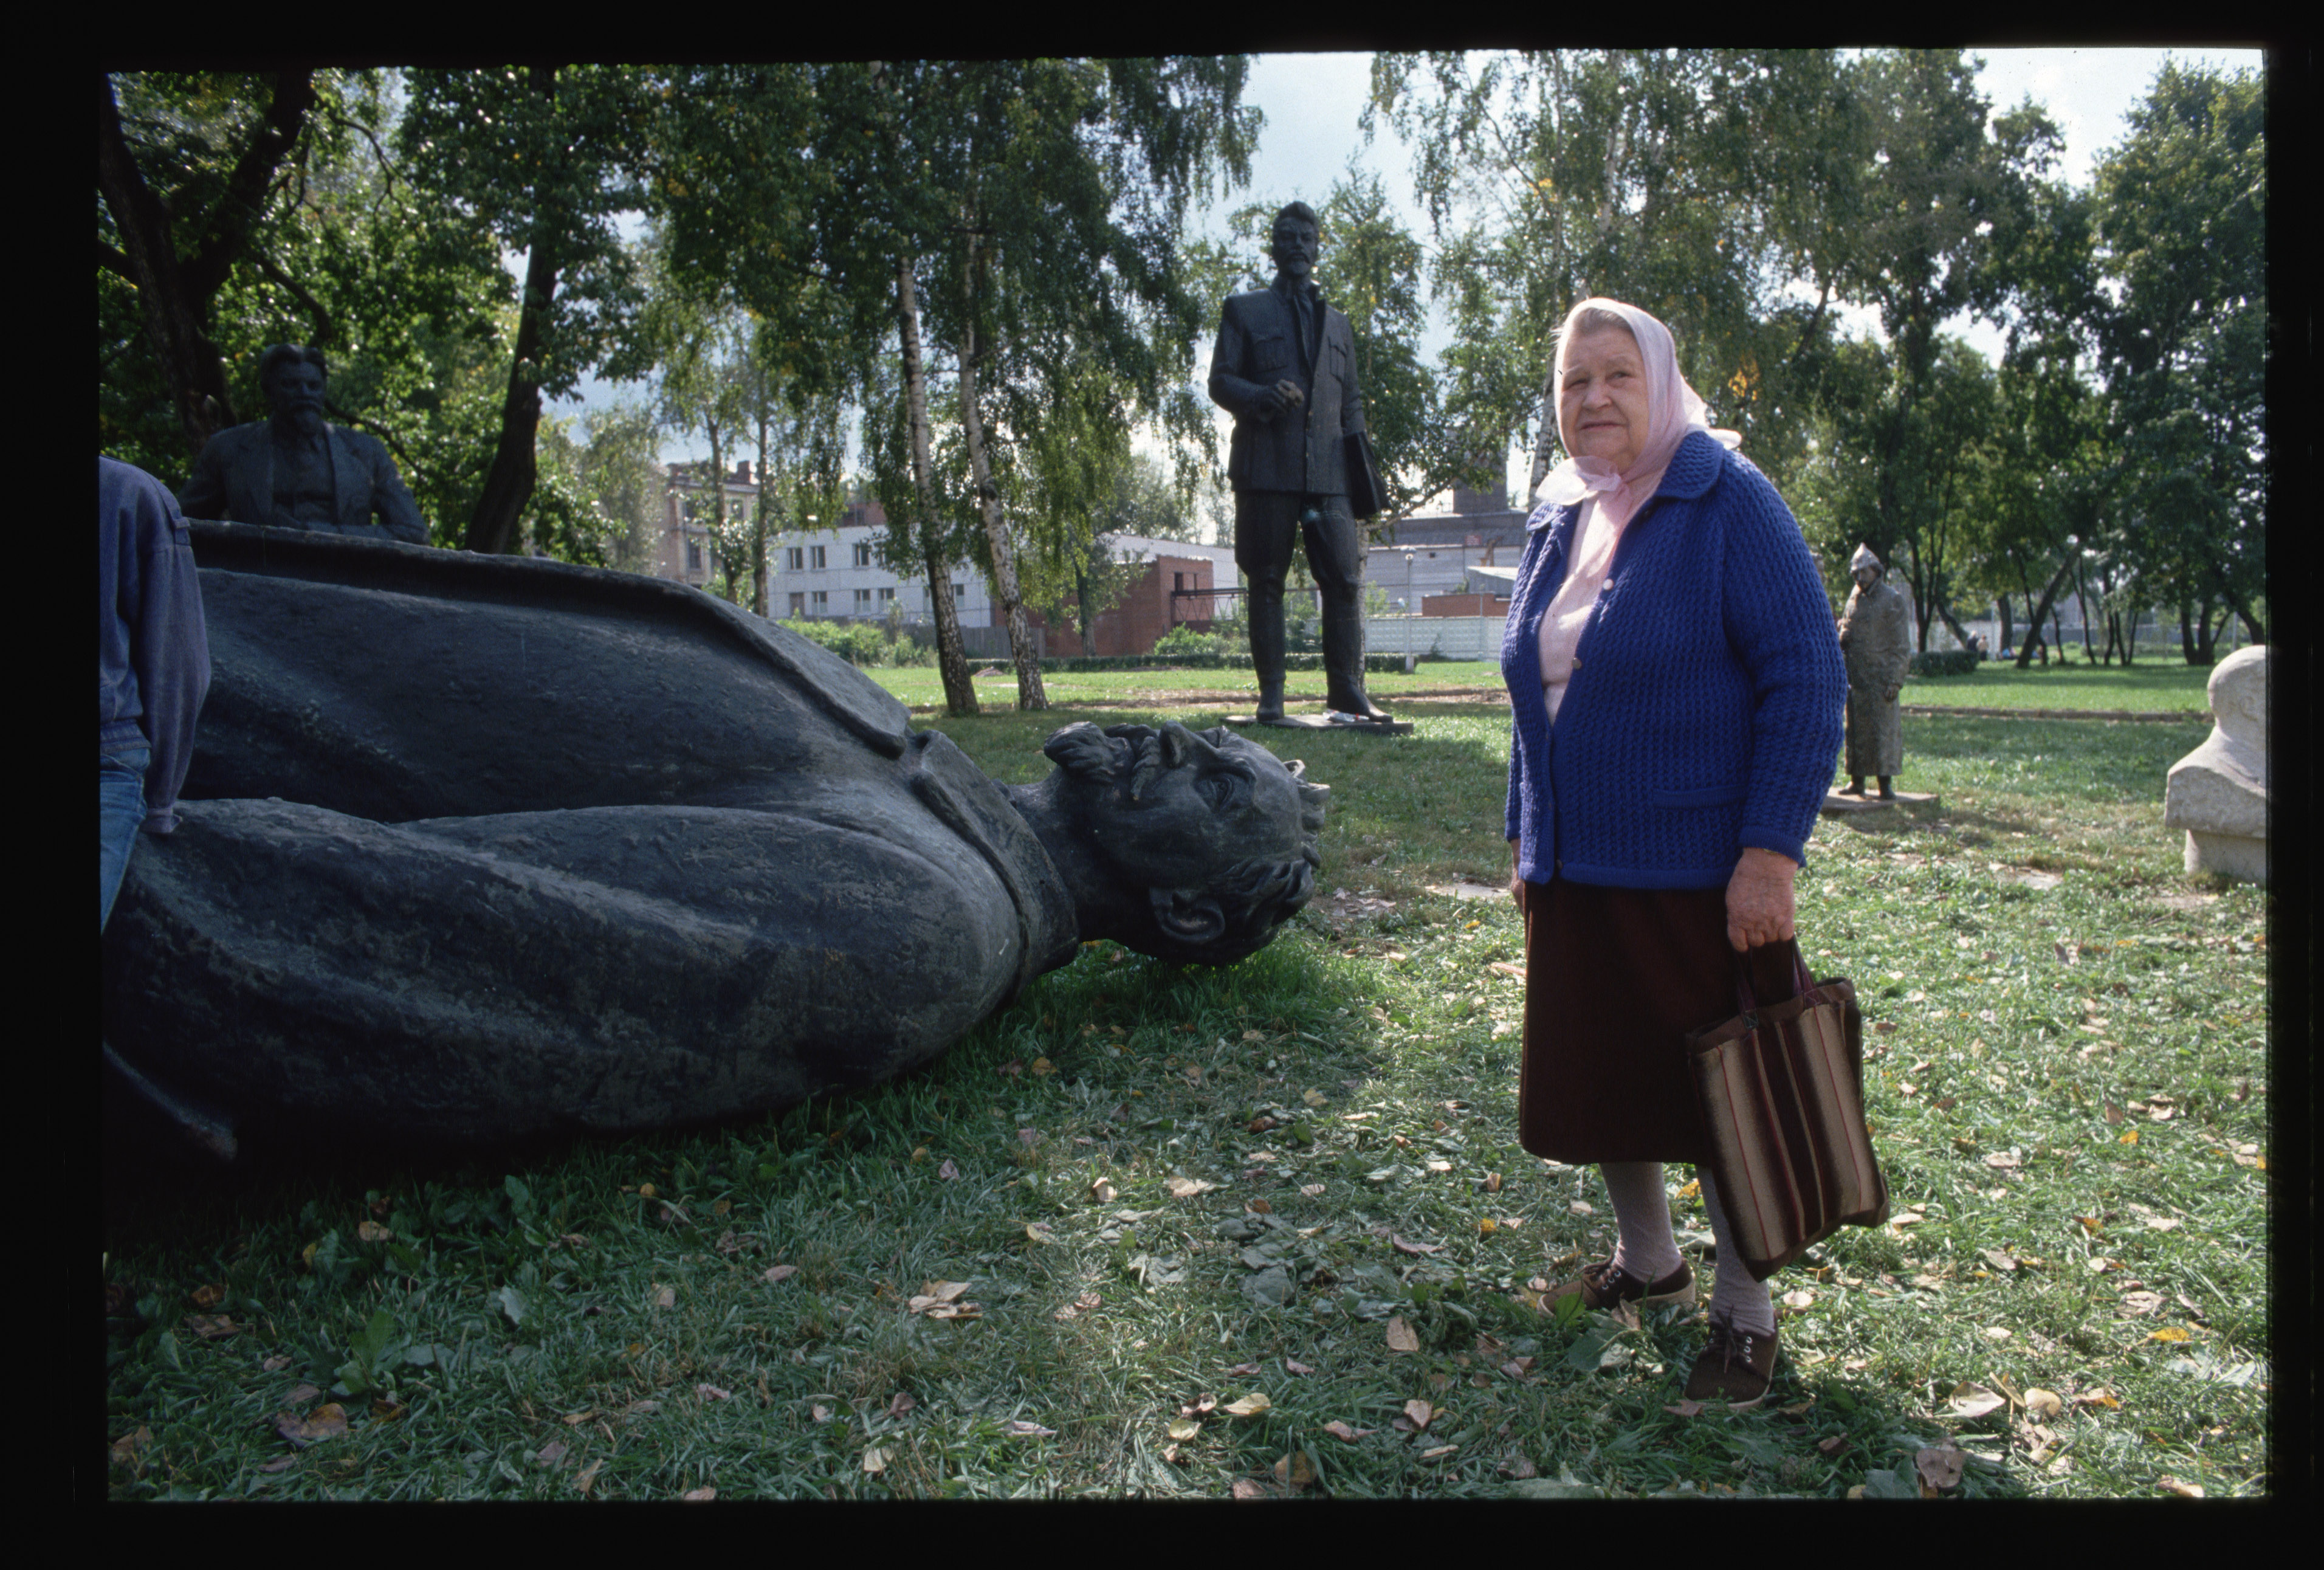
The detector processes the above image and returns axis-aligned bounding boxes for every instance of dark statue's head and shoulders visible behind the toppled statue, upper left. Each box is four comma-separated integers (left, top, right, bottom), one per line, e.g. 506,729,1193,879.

177,344,428,544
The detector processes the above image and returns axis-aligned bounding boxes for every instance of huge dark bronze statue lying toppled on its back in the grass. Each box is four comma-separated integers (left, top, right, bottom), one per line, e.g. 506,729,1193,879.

105,523,1327,1149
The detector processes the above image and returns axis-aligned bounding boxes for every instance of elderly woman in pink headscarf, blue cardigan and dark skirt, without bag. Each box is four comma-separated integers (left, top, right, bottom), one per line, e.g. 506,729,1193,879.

1501,300,1848,1407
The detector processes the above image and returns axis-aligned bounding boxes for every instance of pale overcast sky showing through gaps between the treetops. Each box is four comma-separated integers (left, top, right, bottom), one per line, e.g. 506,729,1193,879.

608,49,2261,504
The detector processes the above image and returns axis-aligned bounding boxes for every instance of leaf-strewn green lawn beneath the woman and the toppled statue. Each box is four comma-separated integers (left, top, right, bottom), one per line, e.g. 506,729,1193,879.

105,707,2273,1500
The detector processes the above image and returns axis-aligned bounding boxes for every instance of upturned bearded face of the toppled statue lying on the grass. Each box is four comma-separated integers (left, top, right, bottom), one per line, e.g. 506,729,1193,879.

1085,726,1301,889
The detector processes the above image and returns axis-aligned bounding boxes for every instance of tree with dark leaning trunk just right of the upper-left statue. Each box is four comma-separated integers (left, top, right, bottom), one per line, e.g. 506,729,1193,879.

402,65,648,554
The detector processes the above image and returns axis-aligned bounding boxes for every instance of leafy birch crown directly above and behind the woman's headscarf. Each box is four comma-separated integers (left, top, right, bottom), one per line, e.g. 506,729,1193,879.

1364,49,1866,504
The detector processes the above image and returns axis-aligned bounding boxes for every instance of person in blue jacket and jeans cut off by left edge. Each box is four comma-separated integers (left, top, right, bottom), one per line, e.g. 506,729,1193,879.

98,456,209,932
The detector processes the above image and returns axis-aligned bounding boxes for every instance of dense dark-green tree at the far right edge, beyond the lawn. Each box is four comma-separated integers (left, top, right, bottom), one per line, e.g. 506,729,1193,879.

2094,63,2268,665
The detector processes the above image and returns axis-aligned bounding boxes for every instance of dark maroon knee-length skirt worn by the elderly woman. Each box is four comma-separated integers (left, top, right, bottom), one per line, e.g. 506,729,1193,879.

1518,877,1799,1163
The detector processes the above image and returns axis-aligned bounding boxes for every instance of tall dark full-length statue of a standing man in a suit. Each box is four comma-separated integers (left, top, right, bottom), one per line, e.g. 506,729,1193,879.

1211,202,1387,721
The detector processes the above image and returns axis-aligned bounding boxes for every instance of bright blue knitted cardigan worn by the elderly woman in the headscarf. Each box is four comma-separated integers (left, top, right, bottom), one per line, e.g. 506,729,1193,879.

1501,433,1848,889
